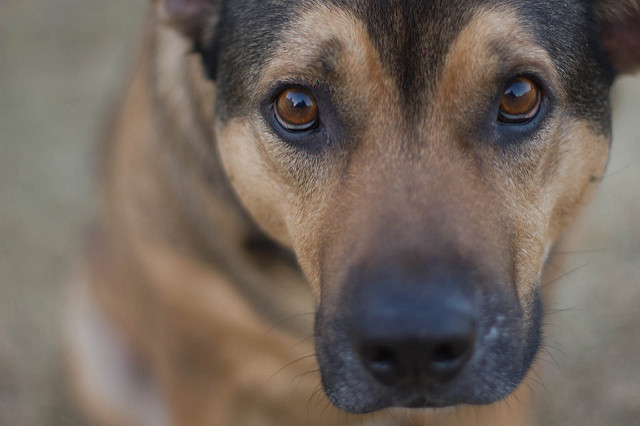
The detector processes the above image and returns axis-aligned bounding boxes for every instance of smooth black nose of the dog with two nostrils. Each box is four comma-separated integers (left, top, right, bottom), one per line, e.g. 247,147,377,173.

349,283,476,387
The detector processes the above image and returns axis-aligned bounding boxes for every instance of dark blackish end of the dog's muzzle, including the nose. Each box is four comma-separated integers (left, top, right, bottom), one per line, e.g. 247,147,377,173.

316,264,540,413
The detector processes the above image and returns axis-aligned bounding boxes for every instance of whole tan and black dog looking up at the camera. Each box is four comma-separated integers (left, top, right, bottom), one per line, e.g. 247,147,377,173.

69,0,640,425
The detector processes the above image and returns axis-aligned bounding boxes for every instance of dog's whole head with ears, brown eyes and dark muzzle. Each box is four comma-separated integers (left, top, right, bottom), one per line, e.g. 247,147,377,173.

160,0,640,412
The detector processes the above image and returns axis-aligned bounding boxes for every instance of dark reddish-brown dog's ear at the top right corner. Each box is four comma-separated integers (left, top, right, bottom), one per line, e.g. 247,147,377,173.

595,0,640,73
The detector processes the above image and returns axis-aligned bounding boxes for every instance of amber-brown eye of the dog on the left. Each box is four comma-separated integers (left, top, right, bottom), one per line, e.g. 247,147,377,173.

273,87,318,131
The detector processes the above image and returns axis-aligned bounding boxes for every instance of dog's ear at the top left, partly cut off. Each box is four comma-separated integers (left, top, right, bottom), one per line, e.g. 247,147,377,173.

152,0,222,40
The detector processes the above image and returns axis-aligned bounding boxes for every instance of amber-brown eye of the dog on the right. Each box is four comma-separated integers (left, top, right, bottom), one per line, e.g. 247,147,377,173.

498,77,541,124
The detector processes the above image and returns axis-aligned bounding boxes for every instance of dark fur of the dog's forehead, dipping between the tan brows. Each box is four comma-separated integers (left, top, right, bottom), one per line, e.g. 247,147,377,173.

219,0,607,126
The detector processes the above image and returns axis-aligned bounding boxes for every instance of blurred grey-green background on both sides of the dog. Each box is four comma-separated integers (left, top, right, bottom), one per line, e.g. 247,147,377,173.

0,0,640,426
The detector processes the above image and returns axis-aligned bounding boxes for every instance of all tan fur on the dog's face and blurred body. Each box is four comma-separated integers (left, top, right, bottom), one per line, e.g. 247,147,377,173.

71,4,608,426
